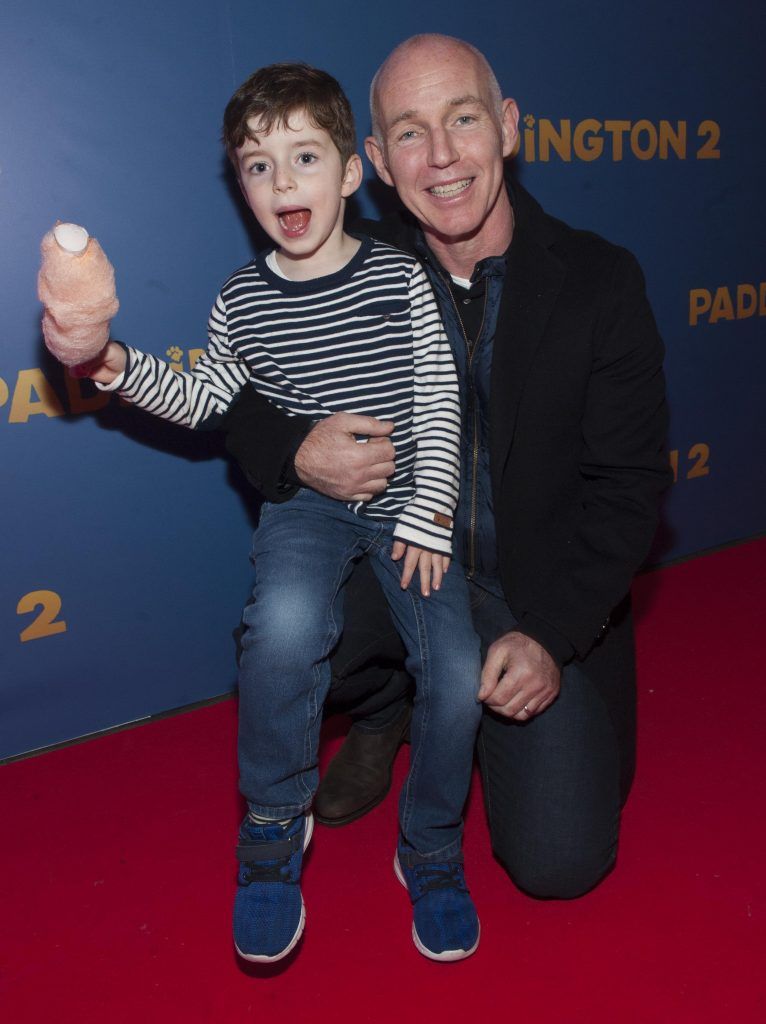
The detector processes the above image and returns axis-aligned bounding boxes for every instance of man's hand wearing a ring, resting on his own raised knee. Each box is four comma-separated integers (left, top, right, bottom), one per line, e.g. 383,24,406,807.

478,632,561,722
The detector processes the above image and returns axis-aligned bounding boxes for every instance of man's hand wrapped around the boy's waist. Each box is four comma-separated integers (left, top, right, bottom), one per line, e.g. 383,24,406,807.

295,413,394,502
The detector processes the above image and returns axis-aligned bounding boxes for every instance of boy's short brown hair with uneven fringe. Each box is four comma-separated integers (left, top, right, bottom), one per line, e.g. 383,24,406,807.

223,63,356,169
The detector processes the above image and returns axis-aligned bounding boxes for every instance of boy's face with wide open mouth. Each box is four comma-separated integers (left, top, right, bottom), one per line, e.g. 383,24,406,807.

236,111,361,259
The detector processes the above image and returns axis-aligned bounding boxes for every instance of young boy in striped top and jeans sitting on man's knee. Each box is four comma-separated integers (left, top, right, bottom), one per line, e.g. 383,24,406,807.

82,65,480,962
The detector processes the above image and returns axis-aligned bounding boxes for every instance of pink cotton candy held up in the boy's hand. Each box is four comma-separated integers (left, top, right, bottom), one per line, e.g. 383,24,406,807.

37,225,120,367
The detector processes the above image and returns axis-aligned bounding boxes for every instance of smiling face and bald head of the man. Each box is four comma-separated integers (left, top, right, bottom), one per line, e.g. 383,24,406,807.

366,45,518,242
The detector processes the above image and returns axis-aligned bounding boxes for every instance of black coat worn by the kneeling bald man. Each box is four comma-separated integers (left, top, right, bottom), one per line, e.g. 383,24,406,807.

364,184,671,658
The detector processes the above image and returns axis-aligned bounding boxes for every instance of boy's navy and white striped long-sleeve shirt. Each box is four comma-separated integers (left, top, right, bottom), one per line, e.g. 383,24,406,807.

102,238,460,554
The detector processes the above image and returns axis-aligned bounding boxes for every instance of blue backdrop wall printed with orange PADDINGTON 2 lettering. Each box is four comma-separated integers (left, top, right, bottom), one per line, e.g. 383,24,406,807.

0,0,766,757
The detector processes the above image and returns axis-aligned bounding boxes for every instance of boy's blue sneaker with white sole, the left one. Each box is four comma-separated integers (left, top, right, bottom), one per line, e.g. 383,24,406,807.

235,814,313,964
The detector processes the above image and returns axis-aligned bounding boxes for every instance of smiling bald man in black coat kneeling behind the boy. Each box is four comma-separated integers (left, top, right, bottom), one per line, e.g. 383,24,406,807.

224,35,669,898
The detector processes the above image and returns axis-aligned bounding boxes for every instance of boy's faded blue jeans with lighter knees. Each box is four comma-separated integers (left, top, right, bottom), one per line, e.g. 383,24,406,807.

239,489,481,861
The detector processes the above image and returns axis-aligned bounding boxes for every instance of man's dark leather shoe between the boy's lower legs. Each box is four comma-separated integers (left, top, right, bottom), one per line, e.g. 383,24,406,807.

313,703,413,825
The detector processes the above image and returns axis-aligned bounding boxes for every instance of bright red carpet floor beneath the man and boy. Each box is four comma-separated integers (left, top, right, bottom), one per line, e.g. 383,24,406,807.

0,541,766,1024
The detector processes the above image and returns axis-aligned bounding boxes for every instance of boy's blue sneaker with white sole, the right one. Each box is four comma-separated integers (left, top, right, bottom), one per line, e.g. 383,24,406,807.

393,851,481,961
